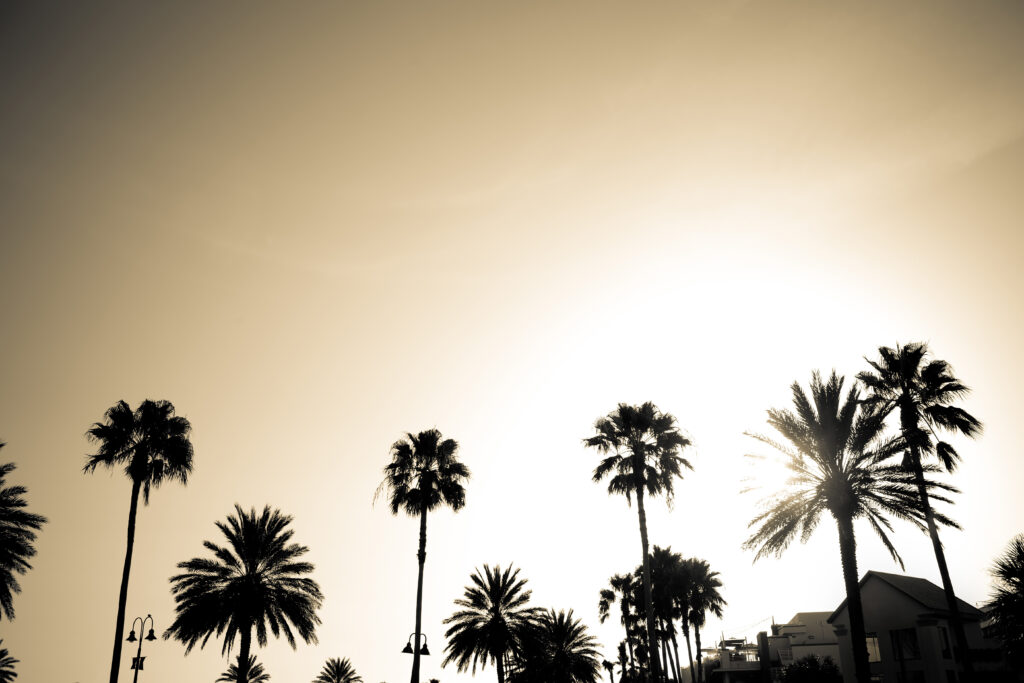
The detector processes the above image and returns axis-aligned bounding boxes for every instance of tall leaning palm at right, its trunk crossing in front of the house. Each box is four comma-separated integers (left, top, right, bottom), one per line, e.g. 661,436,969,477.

857,343,982,681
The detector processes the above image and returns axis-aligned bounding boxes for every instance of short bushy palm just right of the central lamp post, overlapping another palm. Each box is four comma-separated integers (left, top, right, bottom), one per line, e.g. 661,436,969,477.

441,564,540,683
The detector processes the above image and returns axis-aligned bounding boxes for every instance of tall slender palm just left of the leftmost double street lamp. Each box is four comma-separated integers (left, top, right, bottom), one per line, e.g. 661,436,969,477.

83,399,193,683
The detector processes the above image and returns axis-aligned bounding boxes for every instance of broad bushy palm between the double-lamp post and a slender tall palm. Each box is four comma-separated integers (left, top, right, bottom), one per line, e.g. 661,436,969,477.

164,505,324,683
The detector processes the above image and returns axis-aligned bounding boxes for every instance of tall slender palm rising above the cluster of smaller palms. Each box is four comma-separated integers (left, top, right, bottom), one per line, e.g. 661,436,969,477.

584,401,693,680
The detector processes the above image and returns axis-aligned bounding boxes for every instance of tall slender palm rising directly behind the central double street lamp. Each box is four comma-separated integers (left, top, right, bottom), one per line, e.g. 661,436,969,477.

374,429,469,683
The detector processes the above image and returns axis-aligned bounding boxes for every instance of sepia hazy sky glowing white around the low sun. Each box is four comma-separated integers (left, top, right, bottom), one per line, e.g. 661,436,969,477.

0,0,1024,683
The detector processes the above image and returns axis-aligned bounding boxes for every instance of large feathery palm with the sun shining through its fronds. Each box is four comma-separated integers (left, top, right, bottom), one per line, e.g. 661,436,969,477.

743,371,955,683
